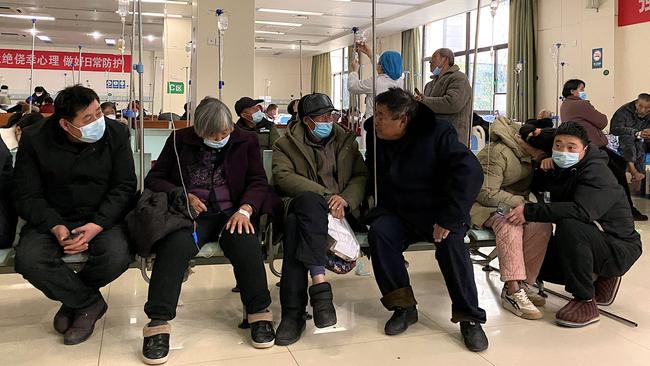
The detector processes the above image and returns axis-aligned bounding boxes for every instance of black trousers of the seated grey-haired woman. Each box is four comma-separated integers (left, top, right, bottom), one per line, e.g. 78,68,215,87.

144,214,271,320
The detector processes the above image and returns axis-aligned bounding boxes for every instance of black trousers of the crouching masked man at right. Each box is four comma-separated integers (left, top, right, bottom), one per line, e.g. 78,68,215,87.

539,219,641,300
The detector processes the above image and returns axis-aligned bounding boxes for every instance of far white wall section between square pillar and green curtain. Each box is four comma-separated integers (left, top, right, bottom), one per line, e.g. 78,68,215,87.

251,56,311,105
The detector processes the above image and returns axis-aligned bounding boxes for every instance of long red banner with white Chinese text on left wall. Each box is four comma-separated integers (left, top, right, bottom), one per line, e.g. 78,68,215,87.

0,49,131,73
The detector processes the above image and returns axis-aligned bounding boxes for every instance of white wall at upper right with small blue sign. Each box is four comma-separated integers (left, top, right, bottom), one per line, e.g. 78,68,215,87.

537,0,650,123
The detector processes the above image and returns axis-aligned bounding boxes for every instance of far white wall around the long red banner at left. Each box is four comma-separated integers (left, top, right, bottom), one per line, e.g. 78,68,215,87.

0,45,156,110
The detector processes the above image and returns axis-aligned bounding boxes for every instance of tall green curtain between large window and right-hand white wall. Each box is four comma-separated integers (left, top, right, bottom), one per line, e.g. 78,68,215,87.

506,0,538,121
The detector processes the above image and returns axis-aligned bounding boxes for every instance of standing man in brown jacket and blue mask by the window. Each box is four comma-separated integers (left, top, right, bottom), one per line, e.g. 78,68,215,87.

415,48,472,146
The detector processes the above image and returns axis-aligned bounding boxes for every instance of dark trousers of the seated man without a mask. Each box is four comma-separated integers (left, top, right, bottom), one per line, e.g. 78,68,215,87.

368,214,486,323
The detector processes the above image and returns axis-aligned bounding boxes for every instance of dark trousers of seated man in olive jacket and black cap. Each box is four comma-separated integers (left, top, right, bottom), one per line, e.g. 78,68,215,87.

280,192,329,317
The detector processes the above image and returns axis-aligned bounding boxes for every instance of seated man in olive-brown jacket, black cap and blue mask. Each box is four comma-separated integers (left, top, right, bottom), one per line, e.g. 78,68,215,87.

273,93,368,346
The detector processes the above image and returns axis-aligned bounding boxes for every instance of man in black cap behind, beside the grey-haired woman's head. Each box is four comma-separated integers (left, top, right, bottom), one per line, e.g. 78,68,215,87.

235,97,280,150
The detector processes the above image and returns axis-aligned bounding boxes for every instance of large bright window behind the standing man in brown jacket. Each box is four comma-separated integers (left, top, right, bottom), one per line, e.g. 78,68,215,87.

422,0,510,114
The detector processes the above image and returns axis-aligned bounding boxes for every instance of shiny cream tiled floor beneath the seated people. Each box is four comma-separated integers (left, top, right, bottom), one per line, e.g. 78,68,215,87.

0,200,650,366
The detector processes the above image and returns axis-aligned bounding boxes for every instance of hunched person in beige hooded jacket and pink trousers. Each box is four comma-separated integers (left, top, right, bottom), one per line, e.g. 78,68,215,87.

471,117,552,319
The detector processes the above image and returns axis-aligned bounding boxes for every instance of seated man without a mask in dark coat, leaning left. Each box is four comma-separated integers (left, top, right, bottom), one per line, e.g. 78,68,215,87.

365,88,488,352
